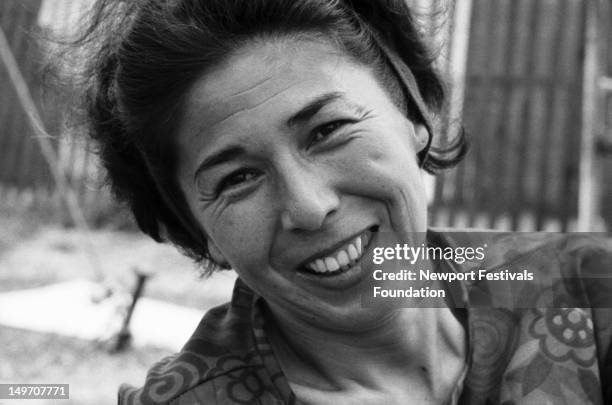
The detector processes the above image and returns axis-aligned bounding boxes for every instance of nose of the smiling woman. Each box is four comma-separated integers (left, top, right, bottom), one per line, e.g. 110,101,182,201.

279,160,340,231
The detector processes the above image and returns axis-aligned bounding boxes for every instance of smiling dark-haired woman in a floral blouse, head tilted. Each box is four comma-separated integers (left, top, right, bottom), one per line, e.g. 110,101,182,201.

75,0,610,404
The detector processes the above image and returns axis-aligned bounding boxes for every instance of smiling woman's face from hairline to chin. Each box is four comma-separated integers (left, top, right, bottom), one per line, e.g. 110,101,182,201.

178,39,427,329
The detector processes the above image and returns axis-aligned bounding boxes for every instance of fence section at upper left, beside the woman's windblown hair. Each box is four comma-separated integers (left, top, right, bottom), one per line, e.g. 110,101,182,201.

0,0,104,218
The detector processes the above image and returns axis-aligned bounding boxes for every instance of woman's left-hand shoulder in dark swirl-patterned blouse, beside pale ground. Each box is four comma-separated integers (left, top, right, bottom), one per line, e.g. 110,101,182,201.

119,281,272,404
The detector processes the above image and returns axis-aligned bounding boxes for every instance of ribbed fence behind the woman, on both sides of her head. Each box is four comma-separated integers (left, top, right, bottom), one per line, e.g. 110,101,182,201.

0,0,612,230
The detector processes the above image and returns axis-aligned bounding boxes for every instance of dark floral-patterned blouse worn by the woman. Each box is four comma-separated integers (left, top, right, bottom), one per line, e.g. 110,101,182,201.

119,230,612,405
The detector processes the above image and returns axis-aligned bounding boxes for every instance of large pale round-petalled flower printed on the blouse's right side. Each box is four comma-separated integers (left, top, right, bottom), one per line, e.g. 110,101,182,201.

529,308,595,367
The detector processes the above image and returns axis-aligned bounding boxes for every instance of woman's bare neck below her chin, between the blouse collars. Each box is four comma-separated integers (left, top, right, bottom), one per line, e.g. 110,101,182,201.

267,308,464,390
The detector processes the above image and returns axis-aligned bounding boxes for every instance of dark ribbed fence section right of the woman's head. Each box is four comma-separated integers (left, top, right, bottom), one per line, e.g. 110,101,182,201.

432,0,602,231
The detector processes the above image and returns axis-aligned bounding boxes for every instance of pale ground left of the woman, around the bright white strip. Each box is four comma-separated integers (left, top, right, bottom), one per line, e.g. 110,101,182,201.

0,205,233,405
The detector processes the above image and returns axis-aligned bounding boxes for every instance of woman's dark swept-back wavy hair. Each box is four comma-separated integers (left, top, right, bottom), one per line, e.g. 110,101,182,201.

72,0,466,268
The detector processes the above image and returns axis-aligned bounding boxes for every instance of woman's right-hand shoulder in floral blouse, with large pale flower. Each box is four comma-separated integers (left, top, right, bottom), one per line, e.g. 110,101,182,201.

436,230,612,403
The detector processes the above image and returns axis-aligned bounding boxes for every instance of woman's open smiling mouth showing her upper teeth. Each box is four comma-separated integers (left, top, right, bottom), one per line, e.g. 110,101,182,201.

302,229,372,276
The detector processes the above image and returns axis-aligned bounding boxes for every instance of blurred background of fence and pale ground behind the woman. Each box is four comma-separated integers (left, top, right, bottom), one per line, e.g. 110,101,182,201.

0,0,612,404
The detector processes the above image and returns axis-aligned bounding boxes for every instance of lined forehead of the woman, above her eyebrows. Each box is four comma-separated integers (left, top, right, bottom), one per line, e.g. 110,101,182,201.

180,39,378,138
